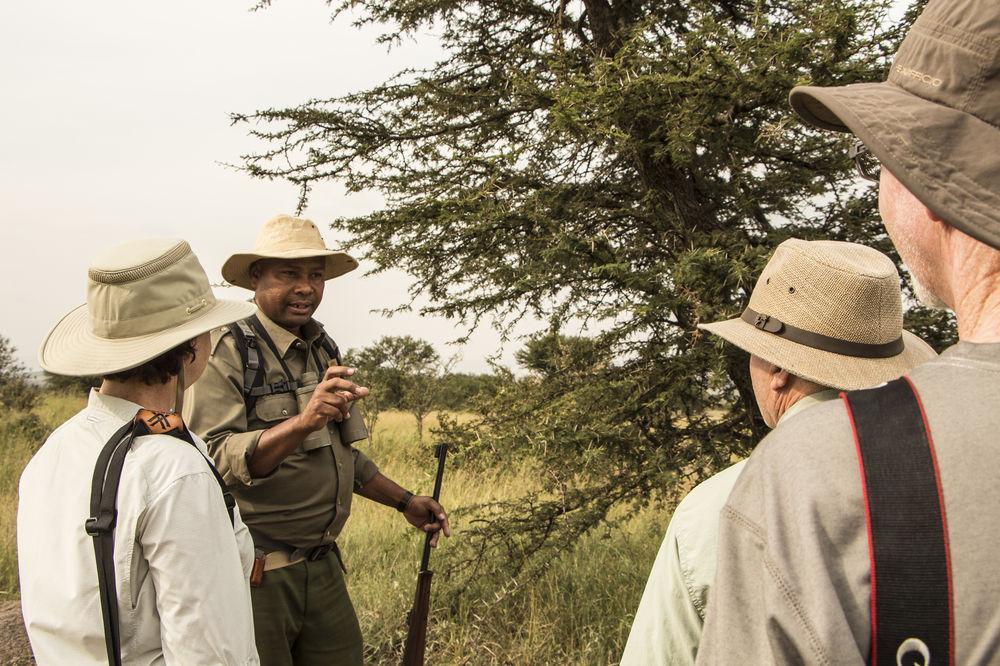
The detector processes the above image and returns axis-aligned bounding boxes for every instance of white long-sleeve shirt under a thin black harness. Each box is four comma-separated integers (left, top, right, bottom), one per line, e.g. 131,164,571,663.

17,391,259,665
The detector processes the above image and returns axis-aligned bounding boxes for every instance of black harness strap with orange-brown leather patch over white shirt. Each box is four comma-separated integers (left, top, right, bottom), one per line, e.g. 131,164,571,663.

84,409,236,666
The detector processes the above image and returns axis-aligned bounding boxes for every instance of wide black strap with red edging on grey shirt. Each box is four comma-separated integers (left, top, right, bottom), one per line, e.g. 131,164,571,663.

841,377,955,666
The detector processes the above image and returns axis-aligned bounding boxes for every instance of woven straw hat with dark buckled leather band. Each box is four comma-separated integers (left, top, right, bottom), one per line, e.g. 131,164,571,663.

699,239,935,390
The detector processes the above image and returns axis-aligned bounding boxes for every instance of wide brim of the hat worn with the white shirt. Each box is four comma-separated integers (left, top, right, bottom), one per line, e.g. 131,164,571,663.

38,300,257,377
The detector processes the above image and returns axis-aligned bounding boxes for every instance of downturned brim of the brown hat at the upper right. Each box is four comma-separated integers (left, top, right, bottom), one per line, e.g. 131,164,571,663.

789,81,1000,249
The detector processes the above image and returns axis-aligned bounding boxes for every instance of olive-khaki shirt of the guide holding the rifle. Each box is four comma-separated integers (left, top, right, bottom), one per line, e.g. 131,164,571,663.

184,310,378,548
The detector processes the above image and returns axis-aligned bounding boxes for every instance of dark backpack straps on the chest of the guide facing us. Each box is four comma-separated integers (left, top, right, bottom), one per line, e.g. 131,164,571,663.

229,315,340,414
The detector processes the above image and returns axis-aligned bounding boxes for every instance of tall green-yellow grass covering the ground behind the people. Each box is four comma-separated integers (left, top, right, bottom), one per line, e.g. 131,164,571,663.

0,394,669,666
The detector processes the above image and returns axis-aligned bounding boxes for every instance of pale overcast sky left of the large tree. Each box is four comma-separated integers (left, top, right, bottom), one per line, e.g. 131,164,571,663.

0,0,537,371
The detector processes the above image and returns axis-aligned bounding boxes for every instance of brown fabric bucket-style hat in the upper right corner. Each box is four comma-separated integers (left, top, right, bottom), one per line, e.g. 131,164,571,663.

789,0,1000,249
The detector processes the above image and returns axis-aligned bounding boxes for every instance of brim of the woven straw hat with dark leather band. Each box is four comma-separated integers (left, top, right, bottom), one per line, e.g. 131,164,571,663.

698,318,937,391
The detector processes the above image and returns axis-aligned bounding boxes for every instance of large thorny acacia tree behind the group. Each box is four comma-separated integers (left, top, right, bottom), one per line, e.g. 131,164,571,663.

234,0,953,578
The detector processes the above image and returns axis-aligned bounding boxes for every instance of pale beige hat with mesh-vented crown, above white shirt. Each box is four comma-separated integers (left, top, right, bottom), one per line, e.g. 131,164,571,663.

38,239,256,376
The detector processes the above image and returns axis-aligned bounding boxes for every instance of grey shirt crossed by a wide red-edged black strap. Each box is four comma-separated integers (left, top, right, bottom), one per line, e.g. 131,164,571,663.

698,343,1000,666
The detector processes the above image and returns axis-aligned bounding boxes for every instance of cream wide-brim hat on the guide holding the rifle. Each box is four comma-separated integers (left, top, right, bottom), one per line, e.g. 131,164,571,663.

222,215,358,289
